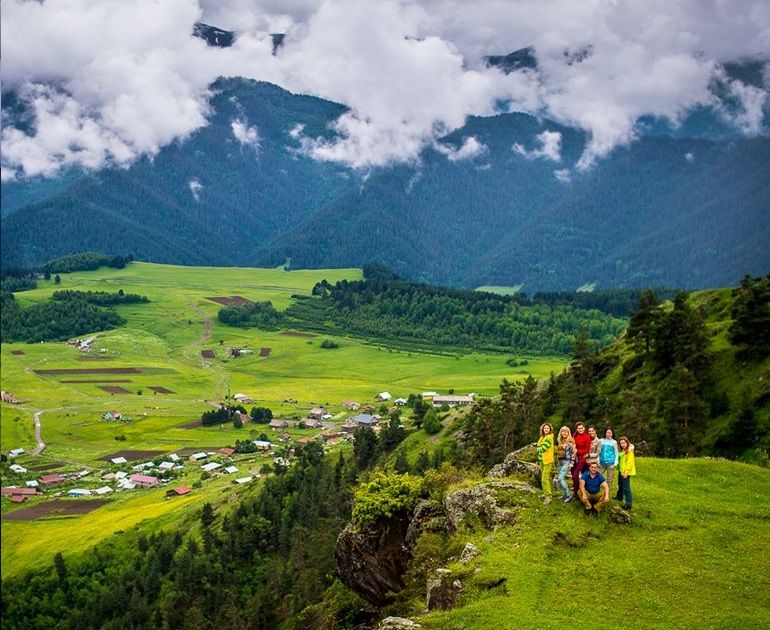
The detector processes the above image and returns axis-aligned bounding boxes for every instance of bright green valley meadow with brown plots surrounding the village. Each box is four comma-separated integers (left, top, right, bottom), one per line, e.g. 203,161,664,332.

0,262,566,577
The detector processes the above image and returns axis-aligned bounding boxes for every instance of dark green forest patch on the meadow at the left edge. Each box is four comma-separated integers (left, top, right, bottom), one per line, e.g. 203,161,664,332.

0,289,147,342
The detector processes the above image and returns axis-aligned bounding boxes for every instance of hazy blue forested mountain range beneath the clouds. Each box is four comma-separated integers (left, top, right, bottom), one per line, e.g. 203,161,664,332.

2,59,770,293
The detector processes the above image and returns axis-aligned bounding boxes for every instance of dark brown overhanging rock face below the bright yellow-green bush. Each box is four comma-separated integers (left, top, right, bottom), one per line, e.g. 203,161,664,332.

334,515,411,608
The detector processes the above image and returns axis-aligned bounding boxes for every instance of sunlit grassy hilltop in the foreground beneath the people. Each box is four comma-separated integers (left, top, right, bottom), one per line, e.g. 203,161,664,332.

413,459,770,630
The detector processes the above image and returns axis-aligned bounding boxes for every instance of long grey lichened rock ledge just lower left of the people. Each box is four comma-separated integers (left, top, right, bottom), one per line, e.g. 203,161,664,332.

444,481,537,531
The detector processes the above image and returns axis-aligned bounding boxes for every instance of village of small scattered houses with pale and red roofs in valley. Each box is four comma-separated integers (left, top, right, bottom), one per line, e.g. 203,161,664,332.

0,391,476,503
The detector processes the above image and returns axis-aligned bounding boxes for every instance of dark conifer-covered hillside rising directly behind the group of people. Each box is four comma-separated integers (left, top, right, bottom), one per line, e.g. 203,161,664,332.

464,276,770,465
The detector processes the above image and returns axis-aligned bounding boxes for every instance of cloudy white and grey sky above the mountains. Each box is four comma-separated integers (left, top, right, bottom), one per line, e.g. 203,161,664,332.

0,0,770,181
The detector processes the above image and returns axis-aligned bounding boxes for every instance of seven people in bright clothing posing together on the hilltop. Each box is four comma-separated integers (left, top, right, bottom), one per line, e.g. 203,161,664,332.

537,421,636,515
